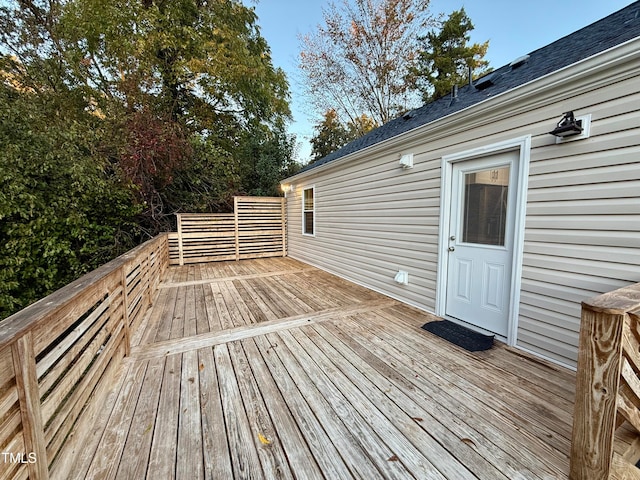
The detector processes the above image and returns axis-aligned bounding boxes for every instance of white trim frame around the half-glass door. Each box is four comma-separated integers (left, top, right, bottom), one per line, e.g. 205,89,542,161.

435,135,531,346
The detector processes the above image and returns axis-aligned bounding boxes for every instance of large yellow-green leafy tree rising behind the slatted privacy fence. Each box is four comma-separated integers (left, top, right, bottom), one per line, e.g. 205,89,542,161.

0,0,290,231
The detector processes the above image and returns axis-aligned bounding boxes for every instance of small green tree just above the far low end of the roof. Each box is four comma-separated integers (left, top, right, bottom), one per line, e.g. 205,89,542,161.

311,109,378,161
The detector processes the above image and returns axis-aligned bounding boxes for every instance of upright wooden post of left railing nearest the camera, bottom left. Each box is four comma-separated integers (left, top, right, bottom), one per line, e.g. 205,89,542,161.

11,332,49,480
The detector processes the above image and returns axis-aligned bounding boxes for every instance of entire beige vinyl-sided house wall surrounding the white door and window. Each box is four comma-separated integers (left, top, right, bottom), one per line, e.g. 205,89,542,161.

286,40,640,366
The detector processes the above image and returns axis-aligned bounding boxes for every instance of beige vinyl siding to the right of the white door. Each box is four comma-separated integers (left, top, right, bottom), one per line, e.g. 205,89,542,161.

517,79,640,365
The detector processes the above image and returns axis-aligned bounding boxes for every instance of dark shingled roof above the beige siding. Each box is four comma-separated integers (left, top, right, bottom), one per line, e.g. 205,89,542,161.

299,1,640,173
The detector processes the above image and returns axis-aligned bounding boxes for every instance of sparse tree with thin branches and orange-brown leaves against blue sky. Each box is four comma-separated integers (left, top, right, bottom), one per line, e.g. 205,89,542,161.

299,0,433,124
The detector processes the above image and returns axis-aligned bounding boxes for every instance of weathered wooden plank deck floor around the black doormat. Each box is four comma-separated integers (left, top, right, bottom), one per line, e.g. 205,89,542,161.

52,258,575,480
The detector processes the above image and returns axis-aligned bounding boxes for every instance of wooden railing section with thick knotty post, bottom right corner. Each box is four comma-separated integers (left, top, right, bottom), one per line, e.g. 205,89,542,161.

570,284,640,480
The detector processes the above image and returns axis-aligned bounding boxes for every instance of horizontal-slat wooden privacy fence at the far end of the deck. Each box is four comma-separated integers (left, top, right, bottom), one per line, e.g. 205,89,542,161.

169,197,286,265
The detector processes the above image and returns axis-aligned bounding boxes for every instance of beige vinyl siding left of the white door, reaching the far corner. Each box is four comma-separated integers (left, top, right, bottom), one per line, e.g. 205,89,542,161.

288,154,440,311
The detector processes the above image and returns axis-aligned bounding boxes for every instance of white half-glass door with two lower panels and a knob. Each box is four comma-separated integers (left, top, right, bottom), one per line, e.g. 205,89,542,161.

445,151,519,337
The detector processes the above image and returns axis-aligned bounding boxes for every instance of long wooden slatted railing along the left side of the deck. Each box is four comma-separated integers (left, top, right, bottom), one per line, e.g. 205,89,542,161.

0,234,169,479
